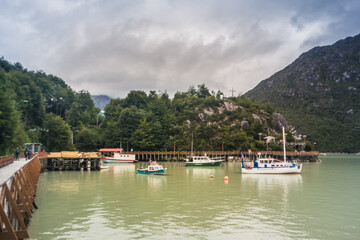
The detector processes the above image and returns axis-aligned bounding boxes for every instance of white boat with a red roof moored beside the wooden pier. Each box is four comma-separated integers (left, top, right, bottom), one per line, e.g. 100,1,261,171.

99,148,137,163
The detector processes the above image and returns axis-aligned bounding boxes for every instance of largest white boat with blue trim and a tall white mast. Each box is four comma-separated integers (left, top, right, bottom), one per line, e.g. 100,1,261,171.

241,128,302,174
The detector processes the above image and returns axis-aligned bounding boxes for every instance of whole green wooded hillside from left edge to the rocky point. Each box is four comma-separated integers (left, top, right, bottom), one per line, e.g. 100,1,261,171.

0,58,309,155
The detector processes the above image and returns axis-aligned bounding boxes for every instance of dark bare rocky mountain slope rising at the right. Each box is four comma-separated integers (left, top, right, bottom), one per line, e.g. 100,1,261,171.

245,34,360,153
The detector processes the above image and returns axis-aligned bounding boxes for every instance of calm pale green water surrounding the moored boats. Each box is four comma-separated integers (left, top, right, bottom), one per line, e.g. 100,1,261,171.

29,155,360,240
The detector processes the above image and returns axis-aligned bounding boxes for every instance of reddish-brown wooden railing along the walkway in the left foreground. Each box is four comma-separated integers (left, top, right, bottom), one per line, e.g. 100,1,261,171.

0,156,41,240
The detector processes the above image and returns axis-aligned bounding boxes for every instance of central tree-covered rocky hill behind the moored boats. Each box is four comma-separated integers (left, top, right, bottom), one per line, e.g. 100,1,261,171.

101,85,300,151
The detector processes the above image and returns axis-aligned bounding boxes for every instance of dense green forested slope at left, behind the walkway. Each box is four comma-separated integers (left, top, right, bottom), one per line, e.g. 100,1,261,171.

0,58,100,155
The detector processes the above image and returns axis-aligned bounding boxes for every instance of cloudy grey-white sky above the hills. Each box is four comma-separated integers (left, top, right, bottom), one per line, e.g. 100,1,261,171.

0,0,360,98
